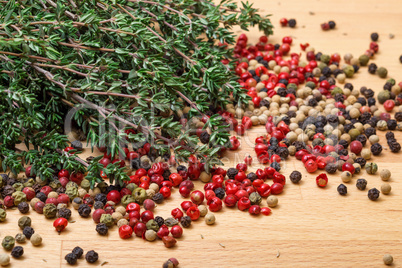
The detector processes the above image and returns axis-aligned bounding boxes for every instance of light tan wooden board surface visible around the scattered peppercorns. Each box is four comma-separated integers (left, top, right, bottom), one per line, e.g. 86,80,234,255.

0,0,402,267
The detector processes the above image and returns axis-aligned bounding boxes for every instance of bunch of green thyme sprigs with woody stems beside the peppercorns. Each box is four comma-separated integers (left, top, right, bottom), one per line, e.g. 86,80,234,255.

0,0,272,182
